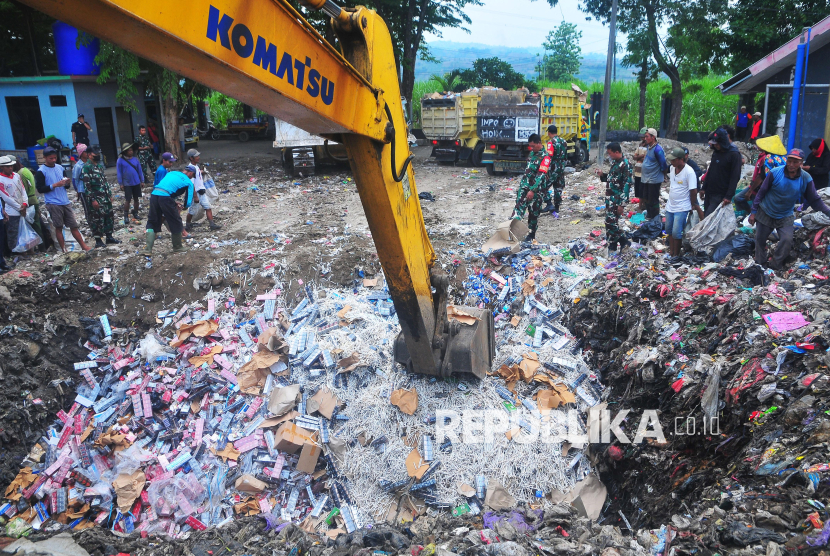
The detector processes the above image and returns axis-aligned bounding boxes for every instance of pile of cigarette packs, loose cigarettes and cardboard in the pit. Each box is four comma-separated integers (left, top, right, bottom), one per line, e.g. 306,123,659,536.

0,236,607,539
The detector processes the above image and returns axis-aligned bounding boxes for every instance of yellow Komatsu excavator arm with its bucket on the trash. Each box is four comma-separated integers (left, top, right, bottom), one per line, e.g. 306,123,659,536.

22,0,495,377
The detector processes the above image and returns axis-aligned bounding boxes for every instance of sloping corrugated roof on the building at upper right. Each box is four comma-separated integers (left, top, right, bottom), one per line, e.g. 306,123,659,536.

718,16,830,95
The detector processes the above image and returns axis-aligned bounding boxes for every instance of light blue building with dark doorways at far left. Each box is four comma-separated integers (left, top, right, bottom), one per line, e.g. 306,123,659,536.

0,75,147,164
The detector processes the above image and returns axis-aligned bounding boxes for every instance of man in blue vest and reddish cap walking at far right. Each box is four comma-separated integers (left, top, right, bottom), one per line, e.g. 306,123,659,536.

749,149,830,270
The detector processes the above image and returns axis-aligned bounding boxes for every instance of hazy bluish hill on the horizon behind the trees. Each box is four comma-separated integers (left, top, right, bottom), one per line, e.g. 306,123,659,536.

415,41,634,83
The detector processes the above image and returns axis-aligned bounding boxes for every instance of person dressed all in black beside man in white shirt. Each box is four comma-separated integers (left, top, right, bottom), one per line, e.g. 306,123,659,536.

698,127,743,216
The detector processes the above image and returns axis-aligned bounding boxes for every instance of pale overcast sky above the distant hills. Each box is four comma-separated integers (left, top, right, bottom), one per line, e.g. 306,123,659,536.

426,0,620,57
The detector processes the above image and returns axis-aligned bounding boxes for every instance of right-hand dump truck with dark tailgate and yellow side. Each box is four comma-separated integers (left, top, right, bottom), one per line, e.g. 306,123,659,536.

477,88,591,176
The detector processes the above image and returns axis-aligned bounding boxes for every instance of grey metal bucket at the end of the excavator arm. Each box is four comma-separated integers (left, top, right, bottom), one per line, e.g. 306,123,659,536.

394,307,496,379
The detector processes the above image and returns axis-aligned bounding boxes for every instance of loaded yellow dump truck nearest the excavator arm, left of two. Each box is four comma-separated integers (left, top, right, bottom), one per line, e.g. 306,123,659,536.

421,91,484,166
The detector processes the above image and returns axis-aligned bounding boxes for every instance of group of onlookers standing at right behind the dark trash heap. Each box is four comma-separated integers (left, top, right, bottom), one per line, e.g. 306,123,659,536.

601,126,830,270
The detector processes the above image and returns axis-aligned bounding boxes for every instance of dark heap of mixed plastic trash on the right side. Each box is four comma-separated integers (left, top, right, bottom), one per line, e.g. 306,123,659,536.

569,245,830,554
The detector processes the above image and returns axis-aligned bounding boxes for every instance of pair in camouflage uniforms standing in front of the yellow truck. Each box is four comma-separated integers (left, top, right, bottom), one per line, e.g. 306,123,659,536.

512,125,568,241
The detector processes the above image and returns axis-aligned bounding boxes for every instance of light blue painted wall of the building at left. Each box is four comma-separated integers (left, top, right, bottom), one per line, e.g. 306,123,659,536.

0,77,78,150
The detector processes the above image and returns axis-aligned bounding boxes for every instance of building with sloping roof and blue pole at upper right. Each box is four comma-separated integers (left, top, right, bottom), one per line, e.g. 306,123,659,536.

718,17,830,150
